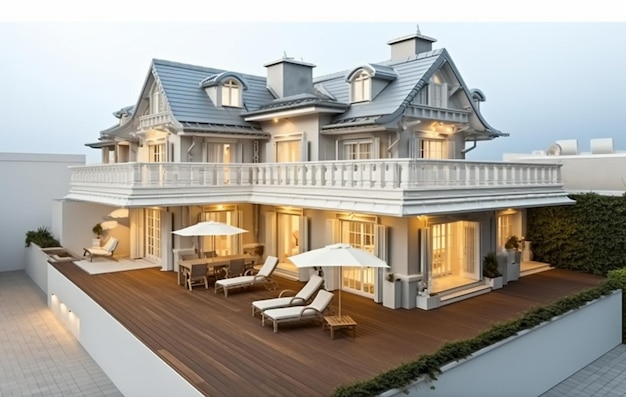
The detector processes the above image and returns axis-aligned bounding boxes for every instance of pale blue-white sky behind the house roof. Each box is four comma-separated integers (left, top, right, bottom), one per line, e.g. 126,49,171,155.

0,0,626,163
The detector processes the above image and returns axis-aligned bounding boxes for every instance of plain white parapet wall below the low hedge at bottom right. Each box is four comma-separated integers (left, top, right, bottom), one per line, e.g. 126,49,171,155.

381,291,622,397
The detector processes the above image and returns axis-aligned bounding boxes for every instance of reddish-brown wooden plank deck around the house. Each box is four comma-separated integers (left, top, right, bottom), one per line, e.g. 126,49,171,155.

54,262,602,397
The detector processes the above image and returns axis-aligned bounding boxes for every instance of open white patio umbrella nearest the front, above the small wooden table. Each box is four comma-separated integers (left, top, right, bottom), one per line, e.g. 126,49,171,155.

289,243,389,317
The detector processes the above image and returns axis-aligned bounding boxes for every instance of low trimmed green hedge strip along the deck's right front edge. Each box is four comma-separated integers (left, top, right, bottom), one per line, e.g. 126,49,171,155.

333,276,626,397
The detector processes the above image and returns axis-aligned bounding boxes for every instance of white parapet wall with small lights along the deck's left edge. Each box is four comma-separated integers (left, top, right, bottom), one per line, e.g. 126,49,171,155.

47,265,202,397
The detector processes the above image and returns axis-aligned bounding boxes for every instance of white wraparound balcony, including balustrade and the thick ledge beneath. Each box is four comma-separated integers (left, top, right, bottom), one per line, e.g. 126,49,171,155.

66,159,571,216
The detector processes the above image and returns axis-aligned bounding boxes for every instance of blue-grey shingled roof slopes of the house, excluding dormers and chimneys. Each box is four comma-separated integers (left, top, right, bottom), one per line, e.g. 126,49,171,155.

103,45,506,136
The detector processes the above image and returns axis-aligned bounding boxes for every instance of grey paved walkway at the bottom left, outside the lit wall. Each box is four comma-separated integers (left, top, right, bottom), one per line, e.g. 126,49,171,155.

0,271,123,397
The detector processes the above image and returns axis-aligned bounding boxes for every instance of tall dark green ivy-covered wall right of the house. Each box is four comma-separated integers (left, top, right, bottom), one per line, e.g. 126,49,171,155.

525,193,626,276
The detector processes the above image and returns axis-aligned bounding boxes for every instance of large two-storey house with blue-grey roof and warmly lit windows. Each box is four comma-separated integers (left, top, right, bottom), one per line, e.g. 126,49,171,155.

60,30,573,309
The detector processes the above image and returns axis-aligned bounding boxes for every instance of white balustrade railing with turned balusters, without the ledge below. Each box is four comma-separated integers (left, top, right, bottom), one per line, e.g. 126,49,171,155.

70,159,561,190
